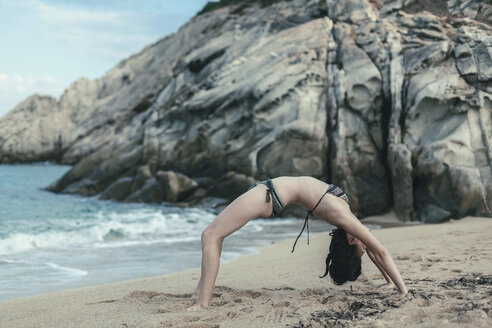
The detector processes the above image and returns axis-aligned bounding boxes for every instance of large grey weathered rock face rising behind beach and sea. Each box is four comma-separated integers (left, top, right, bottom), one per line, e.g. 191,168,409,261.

0,0,492,222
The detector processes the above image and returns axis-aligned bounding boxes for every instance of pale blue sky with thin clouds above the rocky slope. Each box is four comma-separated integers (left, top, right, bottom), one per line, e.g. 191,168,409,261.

0,0,207,118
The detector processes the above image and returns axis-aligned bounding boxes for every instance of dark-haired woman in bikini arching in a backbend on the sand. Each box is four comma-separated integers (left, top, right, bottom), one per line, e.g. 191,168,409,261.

190,177,407,310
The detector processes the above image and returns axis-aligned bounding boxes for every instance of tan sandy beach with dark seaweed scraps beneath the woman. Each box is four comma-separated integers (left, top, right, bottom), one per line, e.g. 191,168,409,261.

0,217,492,327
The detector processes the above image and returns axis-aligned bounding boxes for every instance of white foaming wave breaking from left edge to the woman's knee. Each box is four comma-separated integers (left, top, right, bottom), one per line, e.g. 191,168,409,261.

0,210,213,255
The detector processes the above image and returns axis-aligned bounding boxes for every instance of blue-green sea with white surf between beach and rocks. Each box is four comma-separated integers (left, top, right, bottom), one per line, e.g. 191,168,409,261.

0,163,332,302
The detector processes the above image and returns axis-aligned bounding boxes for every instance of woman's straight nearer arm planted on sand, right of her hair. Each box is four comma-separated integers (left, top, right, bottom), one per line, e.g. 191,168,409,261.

334,211,408,295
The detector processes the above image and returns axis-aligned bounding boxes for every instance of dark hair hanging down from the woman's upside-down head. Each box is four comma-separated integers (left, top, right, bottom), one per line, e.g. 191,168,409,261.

320,228,362,285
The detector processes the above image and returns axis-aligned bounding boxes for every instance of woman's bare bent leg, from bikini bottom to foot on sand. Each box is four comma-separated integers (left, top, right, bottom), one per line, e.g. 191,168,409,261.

190,185,272,308
